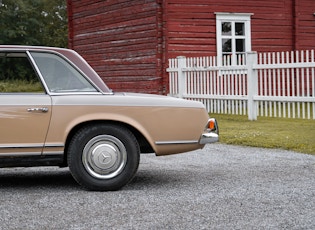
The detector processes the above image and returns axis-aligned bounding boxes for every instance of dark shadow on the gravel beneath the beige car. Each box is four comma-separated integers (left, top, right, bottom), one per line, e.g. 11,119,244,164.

0,167,202,191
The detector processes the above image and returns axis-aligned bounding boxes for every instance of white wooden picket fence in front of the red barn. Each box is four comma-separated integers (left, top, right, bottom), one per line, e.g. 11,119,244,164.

167,50,315,120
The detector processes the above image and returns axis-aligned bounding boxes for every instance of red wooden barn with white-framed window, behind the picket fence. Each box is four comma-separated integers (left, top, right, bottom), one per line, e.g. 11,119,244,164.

68,0,315,94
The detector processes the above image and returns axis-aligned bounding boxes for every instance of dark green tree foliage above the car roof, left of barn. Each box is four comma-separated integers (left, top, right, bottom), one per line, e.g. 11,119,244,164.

0,0,68,47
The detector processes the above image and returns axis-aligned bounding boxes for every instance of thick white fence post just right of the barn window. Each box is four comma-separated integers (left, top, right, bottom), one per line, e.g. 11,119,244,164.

246,52,258,121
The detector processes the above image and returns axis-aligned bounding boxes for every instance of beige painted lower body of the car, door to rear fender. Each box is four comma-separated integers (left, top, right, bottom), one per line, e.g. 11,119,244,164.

0,94,215,155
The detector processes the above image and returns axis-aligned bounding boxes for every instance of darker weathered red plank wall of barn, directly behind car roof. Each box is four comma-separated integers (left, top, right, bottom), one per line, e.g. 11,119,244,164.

68,0,165,94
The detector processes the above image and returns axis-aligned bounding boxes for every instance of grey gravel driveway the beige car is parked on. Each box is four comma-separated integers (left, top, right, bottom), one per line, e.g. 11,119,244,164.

0,143,315,230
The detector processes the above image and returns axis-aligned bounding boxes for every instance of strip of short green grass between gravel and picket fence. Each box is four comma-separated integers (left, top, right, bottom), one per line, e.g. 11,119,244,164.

211,114,315,155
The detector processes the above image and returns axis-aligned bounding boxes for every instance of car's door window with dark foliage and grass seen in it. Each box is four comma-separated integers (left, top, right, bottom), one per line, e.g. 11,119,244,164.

0,52,45,93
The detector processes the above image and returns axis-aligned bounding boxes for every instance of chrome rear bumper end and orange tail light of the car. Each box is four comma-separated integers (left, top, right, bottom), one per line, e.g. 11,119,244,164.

199,118,219,145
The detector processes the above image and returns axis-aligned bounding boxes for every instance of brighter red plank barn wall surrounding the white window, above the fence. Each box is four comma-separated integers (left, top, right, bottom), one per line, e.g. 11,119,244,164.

165,0,315,58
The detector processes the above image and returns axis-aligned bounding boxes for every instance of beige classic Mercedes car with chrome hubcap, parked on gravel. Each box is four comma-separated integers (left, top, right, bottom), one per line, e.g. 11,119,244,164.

0,45,219,191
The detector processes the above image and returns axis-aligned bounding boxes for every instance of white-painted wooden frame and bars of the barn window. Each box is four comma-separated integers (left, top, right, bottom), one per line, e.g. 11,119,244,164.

215,12,253,66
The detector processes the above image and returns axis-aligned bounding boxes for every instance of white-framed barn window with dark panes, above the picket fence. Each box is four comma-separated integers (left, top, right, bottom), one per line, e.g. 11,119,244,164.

215,13,252,65
